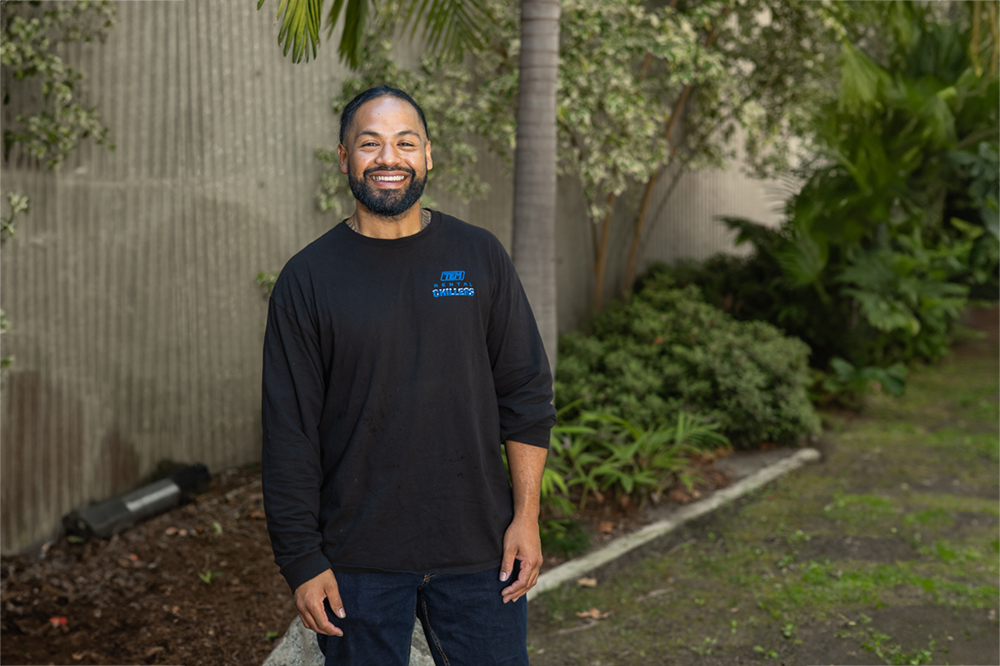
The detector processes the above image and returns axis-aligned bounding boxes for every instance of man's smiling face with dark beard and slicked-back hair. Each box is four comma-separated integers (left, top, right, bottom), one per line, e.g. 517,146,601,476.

337,96,434,217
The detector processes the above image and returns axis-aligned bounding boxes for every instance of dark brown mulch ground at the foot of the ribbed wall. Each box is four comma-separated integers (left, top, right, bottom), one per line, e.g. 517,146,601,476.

0,468,296,666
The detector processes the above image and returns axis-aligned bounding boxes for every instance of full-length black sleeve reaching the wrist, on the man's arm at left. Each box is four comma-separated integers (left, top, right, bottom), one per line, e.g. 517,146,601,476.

261,296,330,590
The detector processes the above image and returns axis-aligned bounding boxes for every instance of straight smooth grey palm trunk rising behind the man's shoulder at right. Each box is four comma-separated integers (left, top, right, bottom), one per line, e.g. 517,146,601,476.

512,0,560,371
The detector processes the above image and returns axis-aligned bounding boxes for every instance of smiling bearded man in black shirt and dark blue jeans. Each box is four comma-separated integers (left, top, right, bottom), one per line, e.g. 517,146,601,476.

263,86,555,666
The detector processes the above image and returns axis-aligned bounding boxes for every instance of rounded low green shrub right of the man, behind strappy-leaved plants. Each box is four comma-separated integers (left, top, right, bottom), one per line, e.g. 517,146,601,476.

556,273,819,447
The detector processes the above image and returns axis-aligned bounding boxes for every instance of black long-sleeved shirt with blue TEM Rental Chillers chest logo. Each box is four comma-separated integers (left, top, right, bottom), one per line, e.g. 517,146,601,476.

262,211,555,589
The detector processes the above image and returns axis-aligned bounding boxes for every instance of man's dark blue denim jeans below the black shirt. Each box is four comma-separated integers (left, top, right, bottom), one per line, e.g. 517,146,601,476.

316,564,528,666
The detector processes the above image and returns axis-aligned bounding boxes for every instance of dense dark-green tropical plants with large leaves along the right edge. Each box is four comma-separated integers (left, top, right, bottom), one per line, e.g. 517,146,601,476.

652,2,1000,387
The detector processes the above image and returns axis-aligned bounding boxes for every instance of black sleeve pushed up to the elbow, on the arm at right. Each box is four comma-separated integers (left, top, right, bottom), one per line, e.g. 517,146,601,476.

486,242,556,448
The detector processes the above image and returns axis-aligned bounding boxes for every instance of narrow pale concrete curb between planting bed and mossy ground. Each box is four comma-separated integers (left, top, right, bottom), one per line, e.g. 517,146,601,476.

527,449,820,601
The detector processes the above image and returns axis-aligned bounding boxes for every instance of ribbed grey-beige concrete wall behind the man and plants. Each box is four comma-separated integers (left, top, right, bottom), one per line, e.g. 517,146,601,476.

0,0,780,552
